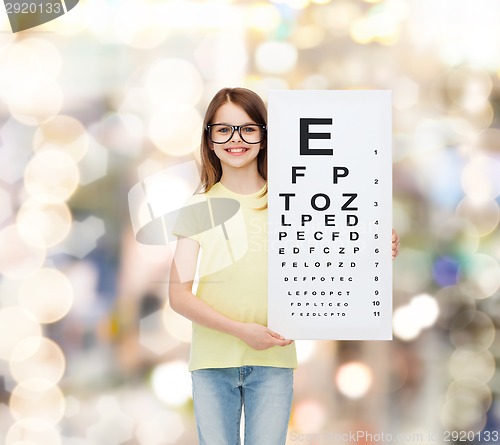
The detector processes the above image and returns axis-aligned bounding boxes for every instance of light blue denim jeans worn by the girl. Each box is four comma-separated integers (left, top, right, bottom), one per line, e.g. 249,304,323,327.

191,366,293,445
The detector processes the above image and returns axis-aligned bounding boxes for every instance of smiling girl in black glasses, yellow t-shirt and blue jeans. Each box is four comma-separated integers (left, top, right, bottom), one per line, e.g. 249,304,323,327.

169,88,399,445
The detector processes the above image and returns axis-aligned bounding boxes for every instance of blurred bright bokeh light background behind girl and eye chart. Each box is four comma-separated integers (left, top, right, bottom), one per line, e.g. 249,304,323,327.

0,0,500,445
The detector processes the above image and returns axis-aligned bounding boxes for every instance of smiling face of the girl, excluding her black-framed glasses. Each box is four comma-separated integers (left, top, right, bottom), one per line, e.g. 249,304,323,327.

210,102,261,172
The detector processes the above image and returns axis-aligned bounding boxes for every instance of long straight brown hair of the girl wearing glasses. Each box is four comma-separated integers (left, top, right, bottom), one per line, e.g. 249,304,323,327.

200,88,267,192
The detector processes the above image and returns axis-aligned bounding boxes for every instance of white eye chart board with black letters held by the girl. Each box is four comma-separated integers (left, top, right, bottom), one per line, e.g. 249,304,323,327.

268,90,392,340
